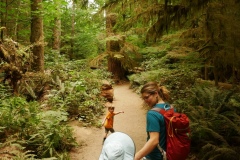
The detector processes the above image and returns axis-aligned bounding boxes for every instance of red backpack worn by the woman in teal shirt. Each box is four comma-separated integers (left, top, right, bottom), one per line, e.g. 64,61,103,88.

152,107,190,160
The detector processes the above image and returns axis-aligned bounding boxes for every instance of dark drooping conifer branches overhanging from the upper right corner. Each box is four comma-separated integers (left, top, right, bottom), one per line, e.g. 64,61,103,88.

103,0,240,86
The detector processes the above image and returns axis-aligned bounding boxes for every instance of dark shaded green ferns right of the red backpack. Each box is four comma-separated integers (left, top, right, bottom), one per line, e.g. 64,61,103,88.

188,86,240,160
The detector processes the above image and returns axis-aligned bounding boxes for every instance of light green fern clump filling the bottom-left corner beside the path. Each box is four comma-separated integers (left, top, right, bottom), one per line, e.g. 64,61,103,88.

0,94,77,158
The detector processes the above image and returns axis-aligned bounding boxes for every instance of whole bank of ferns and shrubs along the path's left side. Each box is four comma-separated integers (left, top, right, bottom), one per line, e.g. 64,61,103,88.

0,53,111,159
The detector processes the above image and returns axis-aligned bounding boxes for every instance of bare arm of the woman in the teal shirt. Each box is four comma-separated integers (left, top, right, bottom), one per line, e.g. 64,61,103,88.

134,132,160,160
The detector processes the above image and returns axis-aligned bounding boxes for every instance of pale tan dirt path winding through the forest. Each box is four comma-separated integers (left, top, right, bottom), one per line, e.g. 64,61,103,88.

70,84,146,160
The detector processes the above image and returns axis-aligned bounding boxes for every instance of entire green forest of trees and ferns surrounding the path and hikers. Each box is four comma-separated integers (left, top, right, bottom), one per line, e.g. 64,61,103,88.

0,0,240,160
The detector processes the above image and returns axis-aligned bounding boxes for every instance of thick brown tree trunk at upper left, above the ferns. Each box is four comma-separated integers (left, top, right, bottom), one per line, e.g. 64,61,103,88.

30,0,44,72
